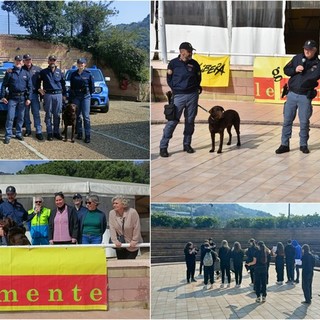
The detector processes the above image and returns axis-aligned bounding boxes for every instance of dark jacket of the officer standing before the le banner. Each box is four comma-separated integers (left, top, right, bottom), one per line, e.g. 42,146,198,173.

283,53,320,95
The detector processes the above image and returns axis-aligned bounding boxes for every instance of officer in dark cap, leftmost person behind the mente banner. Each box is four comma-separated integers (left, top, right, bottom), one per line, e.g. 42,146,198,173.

0,186,28,227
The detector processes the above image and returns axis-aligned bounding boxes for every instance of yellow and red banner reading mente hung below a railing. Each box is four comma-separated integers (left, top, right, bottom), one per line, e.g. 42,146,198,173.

0,245,107,311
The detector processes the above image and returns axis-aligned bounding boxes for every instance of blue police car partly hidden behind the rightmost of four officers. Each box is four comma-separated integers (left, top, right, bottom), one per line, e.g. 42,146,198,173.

65,66,110,113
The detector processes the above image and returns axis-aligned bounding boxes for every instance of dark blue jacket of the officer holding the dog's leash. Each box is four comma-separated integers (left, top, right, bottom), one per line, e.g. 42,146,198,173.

167,56,201,94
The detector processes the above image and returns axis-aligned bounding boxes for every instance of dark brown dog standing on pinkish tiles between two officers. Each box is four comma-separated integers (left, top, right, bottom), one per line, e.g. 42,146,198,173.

208,106,241,153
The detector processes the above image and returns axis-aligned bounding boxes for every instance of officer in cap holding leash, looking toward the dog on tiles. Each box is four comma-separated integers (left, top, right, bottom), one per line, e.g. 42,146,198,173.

160,42,201,157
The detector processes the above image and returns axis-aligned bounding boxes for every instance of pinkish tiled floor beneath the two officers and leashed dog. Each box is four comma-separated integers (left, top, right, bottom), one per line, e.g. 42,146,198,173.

151,100,320,202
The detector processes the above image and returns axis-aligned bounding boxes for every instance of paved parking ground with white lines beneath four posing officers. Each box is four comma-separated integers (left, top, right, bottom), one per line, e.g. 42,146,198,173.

0,100,150,160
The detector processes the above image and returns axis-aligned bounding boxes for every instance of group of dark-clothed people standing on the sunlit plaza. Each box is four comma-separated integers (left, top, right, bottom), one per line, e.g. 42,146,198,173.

184,238,315,304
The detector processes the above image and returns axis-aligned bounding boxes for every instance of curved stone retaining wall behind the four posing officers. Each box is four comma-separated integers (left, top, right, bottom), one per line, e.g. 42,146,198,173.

0,35,150,101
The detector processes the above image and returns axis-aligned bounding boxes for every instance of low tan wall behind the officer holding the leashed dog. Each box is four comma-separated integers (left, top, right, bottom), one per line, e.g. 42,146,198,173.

151,61,254,102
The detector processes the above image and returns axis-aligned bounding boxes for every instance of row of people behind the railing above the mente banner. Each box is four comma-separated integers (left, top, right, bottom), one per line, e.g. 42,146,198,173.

0,186,142,259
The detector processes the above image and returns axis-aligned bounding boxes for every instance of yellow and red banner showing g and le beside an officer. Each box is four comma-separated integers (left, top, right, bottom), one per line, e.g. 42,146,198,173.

253,57,320,104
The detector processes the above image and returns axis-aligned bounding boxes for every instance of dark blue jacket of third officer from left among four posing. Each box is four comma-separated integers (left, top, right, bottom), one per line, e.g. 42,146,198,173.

36,67,66,96
